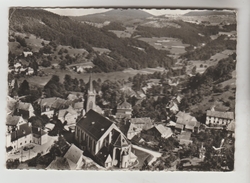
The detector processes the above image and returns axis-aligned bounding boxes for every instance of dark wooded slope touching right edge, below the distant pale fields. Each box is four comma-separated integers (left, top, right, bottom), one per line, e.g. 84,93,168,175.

181,36,236,60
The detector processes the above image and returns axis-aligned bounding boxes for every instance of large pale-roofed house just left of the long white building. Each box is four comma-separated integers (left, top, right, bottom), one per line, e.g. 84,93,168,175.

175,111,200,132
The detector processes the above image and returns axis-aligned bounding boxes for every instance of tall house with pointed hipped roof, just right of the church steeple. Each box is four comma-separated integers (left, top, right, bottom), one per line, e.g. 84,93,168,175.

116,98,133,119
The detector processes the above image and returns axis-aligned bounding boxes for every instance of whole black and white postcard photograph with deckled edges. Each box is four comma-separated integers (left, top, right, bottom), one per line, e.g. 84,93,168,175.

5,7,238,172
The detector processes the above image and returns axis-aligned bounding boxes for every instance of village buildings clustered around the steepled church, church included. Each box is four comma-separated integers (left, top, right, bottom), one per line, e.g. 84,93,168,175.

6,72,235,169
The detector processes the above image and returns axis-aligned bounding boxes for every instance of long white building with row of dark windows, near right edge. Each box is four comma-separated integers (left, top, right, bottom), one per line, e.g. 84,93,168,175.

206,108,234,126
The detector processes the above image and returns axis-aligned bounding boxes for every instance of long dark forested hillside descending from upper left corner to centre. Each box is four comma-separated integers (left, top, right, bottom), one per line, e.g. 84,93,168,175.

10,9,174,72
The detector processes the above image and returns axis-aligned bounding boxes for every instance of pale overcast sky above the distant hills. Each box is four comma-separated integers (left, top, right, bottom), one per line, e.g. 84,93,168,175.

45,8,193,16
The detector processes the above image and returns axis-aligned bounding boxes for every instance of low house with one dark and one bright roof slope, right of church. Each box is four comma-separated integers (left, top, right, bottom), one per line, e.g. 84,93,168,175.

147,124,173,139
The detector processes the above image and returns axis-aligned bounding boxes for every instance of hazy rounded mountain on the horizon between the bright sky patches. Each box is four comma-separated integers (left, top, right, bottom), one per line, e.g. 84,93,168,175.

70,9,153,23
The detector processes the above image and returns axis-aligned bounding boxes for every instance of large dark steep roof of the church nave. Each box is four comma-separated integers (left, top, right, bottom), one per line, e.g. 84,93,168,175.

76,109,113,140
